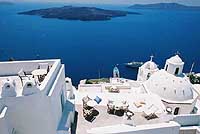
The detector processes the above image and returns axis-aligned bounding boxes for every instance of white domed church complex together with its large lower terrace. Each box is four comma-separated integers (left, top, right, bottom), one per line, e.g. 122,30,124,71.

75,55,200,134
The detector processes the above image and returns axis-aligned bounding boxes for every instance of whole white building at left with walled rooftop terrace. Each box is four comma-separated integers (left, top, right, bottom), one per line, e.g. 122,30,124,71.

0,59,74,134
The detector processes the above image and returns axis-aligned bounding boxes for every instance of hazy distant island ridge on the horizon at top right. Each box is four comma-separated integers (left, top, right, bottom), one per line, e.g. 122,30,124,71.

129,3,200,10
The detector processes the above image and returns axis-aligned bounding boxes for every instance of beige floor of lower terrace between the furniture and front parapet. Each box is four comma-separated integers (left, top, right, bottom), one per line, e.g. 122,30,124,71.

75,104,168,134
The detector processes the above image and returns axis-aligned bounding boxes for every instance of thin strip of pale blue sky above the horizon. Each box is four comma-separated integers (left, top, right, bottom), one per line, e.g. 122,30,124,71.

0,0,200,6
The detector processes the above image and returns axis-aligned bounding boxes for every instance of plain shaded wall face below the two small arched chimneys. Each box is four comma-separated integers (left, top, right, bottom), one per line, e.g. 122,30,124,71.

6,93,56,134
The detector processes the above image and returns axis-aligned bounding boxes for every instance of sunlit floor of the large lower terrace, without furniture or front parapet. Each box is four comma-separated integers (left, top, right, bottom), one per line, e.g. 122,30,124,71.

75,87,169,134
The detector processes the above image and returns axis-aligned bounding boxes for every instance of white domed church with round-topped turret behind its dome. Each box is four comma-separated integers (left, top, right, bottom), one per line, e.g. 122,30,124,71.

144,55,198,115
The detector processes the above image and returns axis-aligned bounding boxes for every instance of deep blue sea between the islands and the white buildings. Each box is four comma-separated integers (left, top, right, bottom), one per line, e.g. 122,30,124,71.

0,3,200,85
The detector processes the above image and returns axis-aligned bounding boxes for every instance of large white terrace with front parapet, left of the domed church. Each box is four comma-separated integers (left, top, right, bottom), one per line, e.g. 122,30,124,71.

75,78,200,134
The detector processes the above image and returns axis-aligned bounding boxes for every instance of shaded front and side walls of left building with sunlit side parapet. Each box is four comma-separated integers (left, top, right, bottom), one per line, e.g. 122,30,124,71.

0,60,70,134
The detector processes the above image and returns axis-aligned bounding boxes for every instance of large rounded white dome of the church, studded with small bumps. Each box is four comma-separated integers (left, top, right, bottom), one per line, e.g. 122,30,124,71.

146,70,193,102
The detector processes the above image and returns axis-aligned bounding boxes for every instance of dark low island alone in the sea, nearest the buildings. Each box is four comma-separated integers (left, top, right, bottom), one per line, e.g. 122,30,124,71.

18,6,140,21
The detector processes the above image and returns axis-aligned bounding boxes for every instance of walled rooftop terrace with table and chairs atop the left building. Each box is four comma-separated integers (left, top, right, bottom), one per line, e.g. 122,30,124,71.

0,60,60,98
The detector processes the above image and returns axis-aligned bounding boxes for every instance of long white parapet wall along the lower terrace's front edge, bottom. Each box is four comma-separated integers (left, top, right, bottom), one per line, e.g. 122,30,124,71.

87,121,180,134
